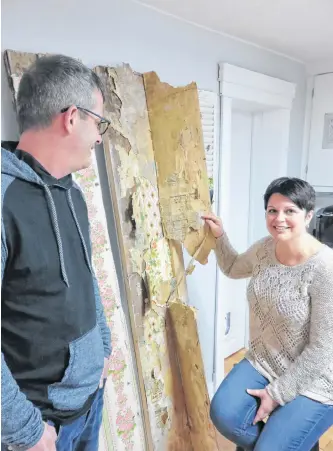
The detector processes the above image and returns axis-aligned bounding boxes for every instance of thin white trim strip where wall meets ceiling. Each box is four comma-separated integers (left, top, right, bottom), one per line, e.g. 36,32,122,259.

131,0,305,64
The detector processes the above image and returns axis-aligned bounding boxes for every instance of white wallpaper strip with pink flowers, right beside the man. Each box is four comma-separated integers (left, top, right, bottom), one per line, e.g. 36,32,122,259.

75,158,145,451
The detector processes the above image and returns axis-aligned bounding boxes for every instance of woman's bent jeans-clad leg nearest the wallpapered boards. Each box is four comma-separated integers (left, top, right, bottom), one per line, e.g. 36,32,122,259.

210,359,268,451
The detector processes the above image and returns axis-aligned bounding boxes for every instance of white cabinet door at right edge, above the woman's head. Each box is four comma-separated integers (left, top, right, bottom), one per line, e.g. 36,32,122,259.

307,73,333,190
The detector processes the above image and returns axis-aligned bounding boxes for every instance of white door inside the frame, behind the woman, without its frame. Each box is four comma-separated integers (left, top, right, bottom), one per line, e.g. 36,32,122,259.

220,103,290,357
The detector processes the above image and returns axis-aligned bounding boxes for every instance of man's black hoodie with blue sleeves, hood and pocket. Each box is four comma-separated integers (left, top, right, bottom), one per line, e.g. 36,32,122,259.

1,149,111,447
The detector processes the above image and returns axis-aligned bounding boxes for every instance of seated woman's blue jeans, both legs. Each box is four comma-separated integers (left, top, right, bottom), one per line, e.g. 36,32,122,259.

210,359,333,451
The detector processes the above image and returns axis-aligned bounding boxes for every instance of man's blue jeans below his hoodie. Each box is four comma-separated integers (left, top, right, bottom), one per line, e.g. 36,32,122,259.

51,388,104,451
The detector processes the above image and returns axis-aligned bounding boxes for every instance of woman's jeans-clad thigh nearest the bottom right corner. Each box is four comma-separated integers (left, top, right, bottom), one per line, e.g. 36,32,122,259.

254,396,333,451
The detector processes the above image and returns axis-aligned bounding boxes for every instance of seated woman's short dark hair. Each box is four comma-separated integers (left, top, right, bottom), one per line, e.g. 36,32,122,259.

264,177,316,213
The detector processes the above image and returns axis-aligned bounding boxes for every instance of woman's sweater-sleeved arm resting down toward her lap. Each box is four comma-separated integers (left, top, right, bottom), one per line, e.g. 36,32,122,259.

267,259,333,405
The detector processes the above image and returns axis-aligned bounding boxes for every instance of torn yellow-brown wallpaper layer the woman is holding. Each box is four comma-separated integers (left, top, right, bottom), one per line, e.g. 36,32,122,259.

144,72,215,263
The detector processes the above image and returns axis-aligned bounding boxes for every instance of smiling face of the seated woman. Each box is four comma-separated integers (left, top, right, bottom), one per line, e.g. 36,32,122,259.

266,194,313,241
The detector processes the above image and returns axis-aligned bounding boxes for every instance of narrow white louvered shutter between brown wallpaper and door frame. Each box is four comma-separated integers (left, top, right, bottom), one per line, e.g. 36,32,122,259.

199,90,218,189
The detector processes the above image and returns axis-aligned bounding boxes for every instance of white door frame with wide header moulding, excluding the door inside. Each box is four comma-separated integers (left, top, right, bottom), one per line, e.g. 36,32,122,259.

213,63,296,391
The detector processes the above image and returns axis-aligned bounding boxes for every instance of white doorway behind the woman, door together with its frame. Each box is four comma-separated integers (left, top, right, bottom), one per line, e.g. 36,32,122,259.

214,63,296,389
